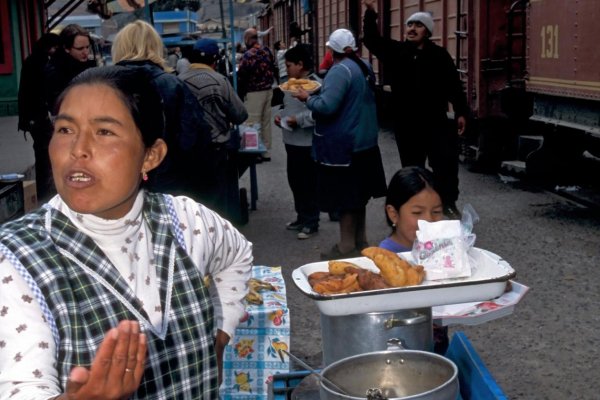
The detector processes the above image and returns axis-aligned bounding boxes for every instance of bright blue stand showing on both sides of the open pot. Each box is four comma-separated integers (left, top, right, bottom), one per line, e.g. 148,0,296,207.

269,332,508,400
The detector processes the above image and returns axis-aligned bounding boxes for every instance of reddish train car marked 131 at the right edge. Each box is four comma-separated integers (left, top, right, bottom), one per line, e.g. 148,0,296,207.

526,0,600,183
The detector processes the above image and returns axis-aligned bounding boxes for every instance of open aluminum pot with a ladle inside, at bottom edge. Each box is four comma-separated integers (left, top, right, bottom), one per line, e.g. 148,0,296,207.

319,350,459,400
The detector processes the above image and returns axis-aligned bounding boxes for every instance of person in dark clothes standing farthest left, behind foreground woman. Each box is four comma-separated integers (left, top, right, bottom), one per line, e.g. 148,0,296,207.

19,33,60,199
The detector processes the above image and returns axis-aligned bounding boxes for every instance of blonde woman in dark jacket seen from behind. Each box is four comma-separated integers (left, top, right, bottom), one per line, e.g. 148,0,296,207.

112,20,211,200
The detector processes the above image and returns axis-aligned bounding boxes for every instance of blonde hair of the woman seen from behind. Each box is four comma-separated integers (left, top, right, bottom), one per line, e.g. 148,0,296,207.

112,20,170,70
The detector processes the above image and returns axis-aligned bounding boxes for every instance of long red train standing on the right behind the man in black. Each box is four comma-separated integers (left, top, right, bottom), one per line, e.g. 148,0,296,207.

260,0,600,181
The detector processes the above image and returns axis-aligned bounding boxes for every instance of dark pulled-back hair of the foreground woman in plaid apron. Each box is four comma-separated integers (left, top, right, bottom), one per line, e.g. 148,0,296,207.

55,65,165,147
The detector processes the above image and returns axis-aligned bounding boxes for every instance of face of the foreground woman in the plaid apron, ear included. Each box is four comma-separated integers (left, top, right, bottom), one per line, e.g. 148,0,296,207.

49,84,166,219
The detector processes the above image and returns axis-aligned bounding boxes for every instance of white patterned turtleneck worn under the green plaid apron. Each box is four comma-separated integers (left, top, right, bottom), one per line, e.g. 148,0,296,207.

0,191,252,400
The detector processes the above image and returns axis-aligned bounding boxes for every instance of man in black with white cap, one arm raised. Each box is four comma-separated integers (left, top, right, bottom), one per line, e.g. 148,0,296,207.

363,0,469,218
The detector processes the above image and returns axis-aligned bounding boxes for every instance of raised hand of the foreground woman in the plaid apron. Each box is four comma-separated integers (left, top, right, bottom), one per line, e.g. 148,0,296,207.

56,321,147,400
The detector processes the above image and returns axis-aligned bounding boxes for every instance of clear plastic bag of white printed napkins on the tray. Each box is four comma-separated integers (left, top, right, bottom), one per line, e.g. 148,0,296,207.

412,204,479,281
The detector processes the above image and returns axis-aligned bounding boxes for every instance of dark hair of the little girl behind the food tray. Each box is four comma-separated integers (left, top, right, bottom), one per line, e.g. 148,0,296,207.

385,166,437,226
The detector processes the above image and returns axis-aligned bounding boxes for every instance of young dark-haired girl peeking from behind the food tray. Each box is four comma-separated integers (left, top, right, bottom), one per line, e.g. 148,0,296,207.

379,166,449,355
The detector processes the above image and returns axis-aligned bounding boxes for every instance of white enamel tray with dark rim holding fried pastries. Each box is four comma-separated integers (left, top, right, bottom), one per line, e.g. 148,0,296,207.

292,248,516,315
